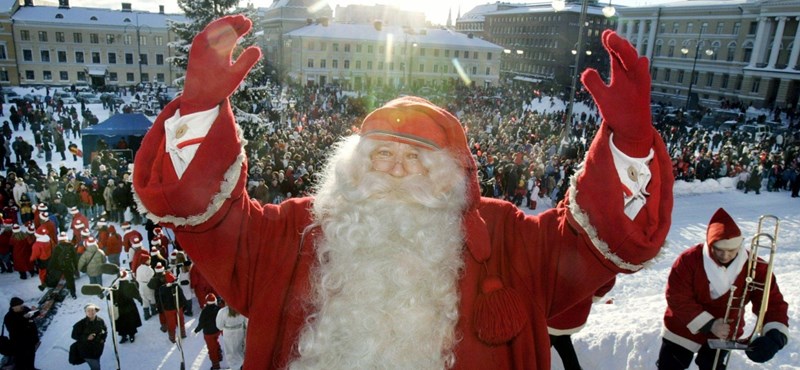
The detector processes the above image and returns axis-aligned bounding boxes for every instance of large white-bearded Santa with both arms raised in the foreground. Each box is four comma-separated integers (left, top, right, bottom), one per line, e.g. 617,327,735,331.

133,16,673,369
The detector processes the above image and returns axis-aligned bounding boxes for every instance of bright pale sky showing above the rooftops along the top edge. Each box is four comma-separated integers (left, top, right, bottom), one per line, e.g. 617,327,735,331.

34,0,669,24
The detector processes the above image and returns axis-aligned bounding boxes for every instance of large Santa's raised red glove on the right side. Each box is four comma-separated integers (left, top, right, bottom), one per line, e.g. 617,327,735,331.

581,30,653,157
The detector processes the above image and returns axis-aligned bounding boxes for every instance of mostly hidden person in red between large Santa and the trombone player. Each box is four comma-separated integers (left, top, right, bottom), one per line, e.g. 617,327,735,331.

547,278,617,370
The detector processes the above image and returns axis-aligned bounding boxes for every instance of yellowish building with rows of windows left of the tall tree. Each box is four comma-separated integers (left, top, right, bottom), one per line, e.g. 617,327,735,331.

8,0,185,87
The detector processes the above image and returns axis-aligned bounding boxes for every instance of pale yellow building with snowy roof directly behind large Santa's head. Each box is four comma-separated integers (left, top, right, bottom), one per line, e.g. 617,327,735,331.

284,23,503,90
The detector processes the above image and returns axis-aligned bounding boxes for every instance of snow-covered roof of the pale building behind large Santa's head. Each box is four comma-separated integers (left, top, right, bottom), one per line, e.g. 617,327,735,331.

287,23,503,49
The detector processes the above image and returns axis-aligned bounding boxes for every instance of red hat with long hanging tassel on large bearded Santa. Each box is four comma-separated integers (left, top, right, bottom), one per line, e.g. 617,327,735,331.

360,96,527,344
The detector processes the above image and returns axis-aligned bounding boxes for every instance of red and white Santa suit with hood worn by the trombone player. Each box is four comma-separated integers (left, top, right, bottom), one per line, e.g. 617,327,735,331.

662,209,789,352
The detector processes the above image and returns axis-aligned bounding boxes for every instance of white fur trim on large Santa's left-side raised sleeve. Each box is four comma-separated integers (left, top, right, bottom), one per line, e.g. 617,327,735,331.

133,124,247,226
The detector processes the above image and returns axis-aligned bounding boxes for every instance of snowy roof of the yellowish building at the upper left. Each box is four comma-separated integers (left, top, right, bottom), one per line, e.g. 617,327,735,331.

11,6,186,28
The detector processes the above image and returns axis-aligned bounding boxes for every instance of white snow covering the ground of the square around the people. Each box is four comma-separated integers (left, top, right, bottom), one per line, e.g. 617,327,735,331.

0,89,800,370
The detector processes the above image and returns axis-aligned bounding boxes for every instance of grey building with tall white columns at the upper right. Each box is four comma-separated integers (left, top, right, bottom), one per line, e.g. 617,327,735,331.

617,0,800,109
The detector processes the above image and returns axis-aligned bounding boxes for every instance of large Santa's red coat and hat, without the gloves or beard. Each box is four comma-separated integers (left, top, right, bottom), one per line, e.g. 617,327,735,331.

133,22,673,369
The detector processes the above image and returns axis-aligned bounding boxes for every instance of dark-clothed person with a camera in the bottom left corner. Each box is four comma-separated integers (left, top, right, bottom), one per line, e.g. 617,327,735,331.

3,297,41,370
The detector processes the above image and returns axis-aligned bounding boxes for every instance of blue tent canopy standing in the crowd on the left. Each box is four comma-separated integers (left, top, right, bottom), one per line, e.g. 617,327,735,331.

81,113,153,165
